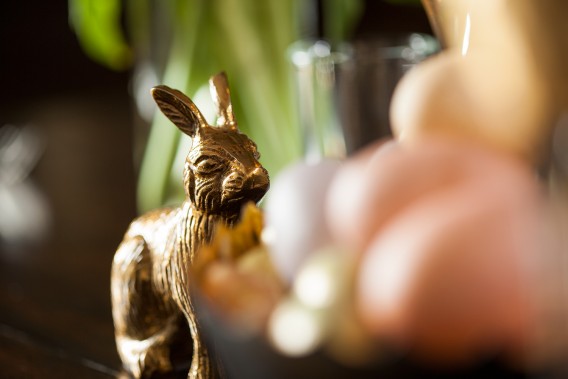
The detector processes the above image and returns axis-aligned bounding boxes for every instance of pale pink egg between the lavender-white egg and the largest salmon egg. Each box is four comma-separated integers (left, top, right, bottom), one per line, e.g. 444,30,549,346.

326,138,494,252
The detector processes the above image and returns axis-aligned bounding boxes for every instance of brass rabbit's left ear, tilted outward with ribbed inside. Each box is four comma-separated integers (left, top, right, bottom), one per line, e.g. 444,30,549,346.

152,85,207,137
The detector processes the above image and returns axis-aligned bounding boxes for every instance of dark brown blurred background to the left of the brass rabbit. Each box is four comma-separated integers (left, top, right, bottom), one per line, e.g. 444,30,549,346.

0,0,135,378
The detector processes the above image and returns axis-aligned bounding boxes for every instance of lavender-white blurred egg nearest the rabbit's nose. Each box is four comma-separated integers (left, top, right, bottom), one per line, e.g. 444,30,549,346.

263,160,340,280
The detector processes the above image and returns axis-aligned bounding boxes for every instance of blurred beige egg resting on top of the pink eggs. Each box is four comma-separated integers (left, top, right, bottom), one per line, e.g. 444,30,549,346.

390,49,551,162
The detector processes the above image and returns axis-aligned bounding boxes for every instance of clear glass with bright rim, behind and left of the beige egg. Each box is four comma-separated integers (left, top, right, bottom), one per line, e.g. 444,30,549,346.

289,34,439,162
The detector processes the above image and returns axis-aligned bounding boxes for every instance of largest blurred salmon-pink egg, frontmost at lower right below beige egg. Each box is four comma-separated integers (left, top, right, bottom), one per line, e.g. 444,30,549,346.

356,143,546,362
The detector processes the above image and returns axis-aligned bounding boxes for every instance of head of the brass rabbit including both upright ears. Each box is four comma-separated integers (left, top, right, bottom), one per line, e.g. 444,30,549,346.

152,73,269,217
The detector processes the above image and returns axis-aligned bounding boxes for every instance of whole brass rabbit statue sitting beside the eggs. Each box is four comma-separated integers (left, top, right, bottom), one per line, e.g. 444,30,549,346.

111,73,269,379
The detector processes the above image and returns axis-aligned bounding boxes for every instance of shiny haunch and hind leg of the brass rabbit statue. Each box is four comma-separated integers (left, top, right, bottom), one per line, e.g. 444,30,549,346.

111,236,182,378
